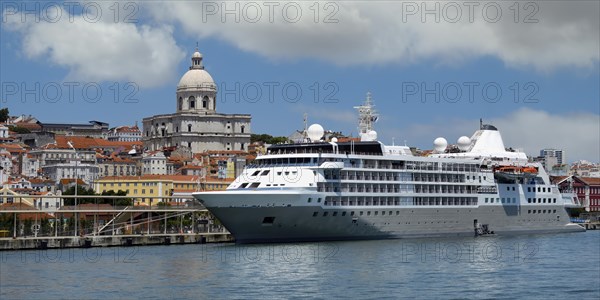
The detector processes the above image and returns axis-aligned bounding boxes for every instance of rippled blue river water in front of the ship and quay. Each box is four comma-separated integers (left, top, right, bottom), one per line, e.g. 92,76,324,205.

0,231,600,299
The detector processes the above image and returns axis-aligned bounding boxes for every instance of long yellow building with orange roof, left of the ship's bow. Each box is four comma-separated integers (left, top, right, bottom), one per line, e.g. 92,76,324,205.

94,175,233,205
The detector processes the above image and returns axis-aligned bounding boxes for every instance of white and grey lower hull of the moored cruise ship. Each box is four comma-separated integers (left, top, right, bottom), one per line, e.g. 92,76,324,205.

193,190,585,243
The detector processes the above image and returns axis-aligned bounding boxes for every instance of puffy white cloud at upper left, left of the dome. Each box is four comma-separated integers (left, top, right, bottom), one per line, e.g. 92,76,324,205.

6,3,185,87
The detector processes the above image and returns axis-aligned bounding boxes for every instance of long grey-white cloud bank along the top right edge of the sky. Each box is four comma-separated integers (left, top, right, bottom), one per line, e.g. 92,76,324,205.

148,1,600,72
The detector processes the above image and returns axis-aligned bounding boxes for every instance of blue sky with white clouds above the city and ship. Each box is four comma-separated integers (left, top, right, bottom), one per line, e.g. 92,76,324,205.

0,1,600,162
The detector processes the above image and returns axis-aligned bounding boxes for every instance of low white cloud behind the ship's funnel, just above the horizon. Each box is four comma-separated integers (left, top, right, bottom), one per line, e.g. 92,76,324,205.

384,108,600,162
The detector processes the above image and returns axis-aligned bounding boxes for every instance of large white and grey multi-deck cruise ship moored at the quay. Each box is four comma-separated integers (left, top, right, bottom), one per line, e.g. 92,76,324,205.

193,95,585,243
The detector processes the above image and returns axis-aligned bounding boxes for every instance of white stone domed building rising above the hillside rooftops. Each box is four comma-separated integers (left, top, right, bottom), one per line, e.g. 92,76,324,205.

142,48,251,153
